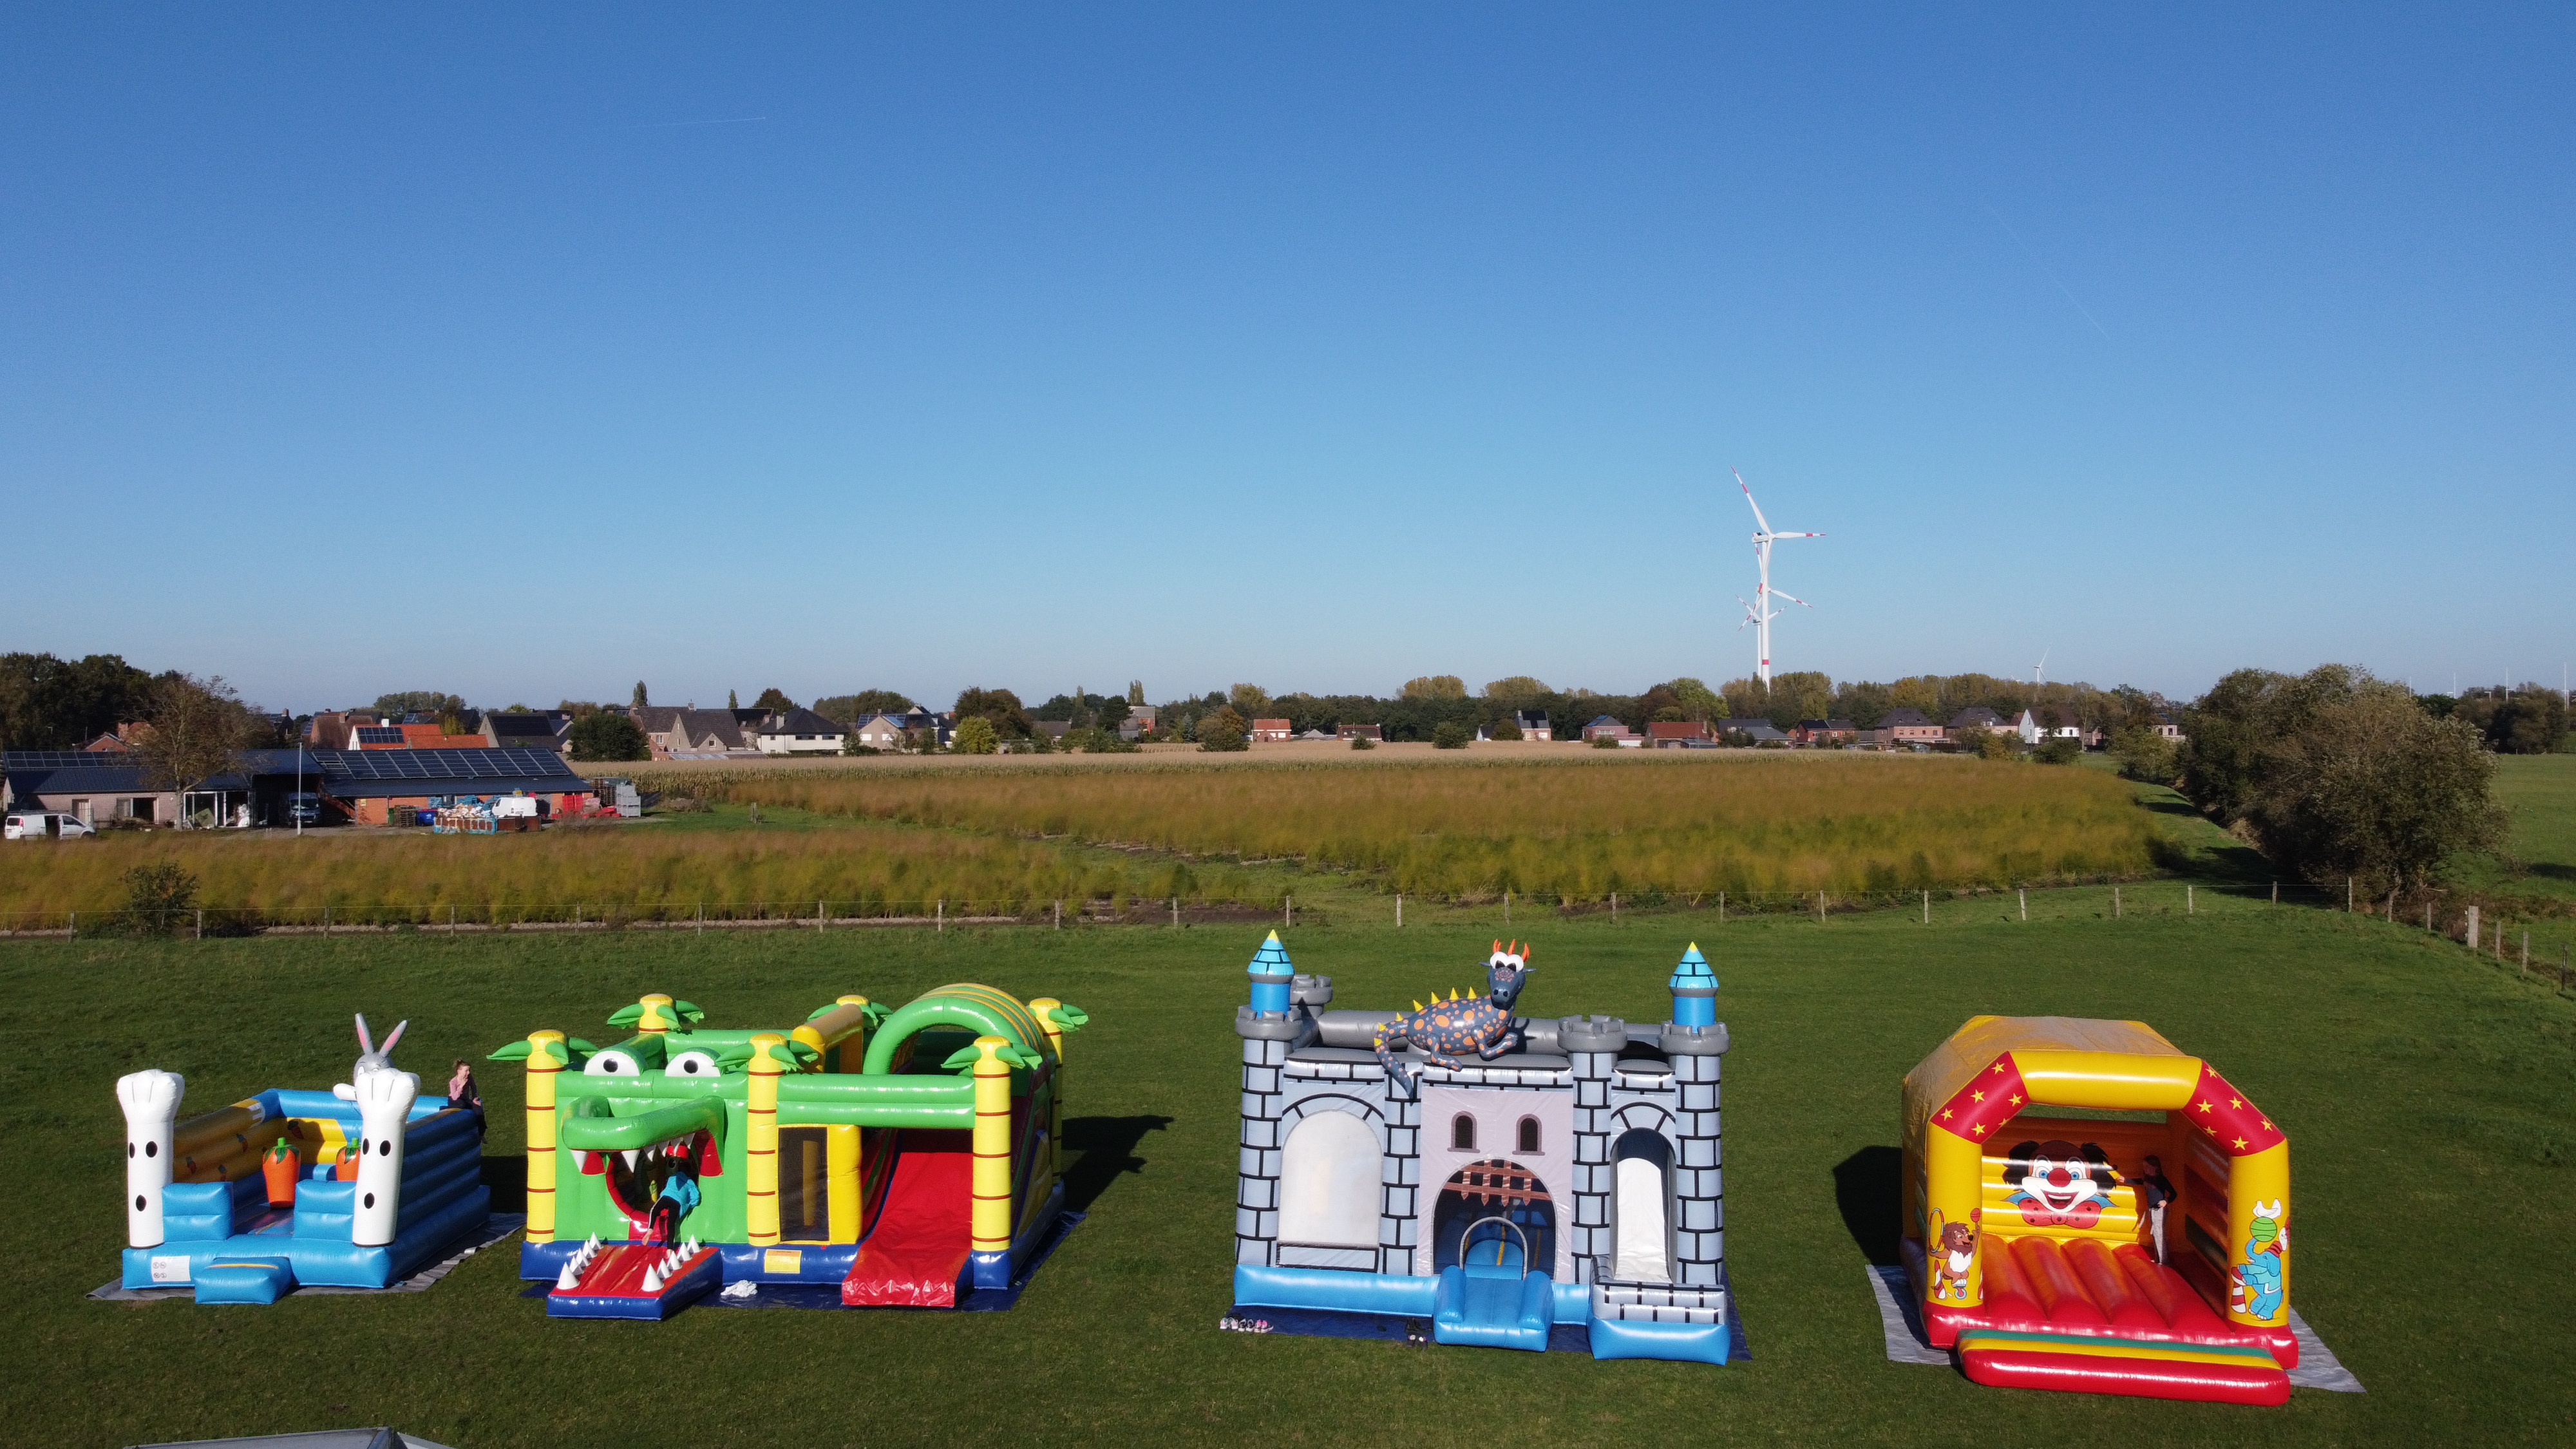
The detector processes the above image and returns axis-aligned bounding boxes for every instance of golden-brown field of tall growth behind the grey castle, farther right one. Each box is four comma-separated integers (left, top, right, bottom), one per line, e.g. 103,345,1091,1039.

665,753,2156,902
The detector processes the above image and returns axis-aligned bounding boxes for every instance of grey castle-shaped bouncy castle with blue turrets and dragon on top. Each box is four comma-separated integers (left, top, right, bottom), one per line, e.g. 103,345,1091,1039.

1231,931,1741,1364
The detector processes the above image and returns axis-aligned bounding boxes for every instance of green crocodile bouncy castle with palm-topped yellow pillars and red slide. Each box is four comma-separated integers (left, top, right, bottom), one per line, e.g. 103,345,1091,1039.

492,985,1087,1318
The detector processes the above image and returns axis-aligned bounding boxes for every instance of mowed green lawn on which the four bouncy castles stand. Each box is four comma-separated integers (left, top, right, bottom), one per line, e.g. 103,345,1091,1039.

0,887,2576,1449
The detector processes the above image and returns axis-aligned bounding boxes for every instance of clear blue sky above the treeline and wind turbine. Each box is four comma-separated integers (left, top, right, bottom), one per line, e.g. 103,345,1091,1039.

0,5,2576,709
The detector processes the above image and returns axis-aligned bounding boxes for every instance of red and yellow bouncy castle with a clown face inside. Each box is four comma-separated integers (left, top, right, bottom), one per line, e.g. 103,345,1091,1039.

1904,1016,2298,1403
